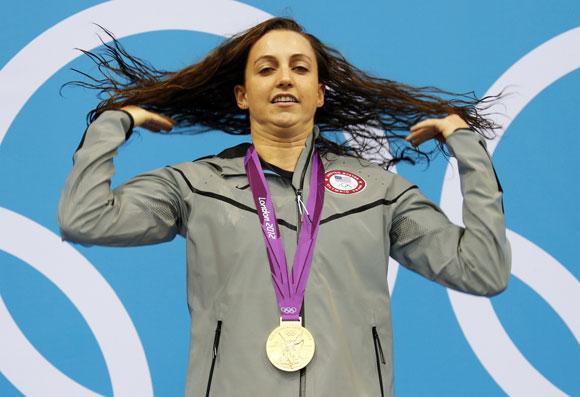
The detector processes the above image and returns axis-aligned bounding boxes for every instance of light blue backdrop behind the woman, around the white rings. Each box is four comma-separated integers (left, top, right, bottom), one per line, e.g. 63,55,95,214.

0,0,580,396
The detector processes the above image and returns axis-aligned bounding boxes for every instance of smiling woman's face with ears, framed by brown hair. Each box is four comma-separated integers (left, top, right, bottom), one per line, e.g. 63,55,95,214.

234,30,324,131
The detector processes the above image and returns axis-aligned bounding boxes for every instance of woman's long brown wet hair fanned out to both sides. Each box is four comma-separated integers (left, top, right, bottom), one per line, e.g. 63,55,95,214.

67,17,502,166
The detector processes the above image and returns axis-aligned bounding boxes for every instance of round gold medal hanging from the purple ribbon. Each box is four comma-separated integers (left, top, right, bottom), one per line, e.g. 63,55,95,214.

266,319,314,372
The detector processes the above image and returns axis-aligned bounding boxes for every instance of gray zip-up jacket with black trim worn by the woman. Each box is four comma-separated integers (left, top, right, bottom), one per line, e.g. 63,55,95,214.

59,111,510,397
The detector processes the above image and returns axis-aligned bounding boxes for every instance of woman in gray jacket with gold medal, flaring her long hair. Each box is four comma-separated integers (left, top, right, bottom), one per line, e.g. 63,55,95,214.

59,18,510,396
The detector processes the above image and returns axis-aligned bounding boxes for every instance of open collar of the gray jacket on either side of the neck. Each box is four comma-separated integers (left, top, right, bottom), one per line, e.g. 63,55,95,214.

203,125,320,189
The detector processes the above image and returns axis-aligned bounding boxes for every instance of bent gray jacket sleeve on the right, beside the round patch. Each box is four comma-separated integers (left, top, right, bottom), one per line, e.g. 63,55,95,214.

389,129,511,296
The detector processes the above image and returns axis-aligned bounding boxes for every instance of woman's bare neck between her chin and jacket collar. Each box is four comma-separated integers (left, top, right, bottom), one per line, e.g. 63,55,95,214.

252,124,312,172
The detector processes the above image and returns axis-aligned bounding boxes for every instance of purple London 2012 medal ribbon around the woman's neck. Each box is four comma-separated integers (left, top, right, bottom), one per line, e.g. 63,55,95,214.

244,145,324,321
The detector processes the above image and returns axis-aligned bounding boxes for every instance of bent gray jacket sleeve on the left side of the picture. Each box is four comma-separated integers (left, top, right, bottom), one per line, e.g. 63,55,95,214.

58,110,186,246
